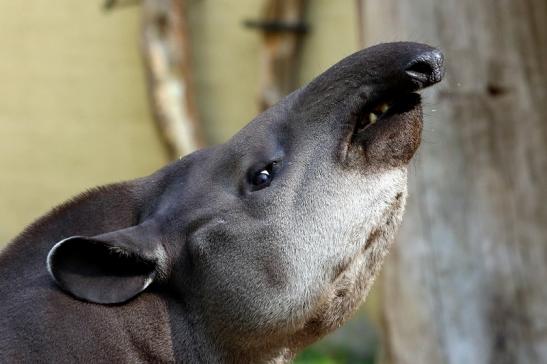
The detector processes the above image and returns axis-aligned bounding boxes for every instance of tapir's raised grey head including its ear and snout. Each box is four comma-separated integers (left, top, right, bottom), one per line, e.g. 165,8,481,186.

48,43,443,356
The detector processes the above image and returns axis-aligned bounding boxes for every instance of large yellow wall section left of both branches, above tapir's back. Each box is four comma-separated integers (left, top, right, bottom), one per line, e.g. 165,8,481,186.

0,0,165,245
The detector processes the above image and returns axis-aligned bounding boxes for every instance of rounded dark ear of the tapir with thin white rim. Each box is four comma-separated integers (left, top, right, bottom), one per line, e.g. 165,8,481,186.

47,226,165,304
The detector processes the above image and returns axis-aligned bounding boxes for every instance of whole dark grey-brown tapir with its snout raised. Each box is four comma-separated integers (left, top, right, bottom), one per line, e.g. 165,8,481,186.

0,42,444,363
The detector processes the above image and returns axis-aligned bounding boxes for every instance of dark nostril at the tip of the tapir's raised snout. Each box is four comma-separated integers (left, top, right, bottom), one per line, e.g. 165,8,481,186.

405,49,444,87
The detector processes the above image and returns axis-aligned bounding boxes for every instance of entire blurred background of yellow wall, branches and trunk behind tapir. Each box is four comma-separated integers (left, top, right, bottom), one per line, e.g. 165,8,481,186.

0,0,547,364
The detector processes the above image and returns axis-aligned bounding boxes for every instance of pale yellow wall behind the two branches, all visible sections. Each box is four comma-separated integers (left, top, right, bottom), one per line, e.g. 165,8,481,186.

0,0,357,246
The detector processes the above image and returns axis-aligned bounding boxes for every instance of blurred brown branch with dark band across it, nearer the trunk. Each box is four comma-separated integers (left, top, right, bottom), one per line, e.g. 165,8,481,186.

244,0,308,110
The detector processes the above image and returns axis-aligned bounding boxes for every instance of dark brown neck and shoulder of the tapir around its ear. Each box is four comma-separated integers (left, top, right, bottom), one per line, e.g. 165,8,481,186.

0,180,174,362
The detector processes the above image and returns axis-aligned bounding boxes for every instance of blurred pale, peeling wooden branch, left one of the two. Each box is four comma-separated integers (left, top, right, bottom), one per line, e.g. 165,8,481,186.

142,0,204,157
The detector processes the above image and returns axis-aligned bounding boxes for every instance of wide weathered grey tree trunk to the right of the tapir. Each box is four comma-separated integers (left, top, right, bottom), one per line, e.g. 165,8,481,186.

359,0,547,364
